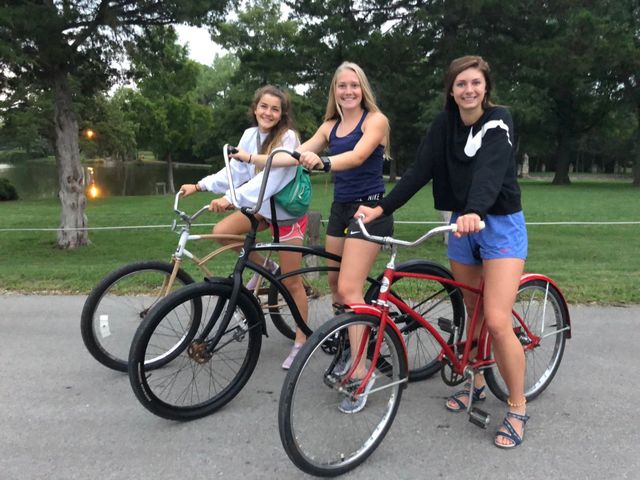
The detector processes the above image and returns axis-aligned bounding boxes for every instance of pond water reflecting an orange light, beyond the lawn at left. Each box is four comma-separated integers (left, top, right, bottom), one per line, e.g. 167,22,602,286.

0,162,212,200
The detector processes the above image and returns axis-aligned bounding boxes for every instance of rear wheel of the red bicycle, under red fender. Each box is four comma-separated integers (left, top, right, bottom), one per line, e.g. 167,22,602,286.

485,280,569,402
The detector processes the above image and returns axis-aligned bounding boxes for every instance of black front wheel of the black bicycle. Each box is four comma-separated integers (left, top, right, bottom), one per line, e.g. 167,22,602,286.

129,281,264,420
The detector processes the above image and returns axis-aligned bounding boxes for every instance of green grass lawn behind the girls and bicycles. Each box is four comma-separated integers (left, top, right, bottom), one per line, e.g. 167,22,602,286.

0,175,640,304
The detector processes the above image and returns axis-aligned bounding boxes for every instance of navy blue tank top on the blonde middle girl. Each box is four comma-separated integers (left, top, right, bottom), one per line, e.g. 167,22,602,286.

329,110,384,203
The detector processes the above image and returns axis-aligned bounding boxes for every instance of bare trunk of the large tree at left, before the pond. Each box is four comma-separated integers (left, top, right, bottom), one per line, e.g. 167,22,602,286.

53,72,89,248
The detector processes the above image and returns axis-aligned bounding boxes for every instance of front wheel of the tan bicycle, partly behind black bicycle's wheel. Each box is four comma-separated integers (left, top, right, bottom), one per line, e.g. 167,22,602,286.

80,260,194,372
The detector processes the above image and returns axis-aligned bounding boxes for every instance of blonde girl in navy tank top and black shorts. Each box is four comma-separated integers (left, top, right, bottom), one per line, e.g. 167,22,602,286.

298,62,393,413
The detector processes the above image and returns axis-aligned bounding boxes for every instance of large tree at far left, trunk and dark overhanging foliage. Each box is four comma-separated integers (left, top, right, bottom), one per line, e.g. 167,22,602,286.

0,0,229,248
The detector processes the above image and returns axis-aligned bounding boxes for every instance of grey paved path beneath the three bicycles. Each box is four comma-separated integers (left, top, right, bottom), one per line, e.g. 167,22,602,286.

0,295,640,480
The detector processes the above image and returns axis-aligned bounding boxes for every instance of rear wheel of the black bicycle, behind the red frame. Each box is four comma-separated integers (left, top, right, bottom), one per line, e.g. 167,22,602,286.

365,260,465,382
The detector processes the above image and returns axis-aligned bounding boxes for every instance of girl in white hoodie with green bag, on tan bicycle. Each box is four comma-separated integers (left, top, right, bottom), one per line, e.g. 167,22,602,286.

180,85,308,369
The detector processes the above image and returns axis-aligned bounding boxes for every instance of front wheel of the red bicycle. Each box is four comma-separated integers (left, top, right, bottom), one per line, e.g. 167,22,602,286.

278,314,407,476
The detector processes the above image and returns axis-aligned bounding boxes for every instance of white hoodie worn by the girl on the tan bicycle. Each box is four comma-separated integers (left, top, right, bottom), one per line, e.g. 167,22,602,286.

198,127,300,221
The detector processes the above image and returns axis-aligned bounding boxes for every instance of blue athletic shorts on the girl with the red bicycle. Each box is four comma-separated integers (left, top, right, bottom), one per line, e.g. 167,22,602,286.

447,211,527,265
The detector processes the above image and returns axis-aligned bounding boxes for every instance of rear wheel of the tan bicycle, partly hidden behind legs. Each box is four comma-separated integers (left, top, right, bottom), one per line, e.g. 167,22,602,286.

267,254,340,340
